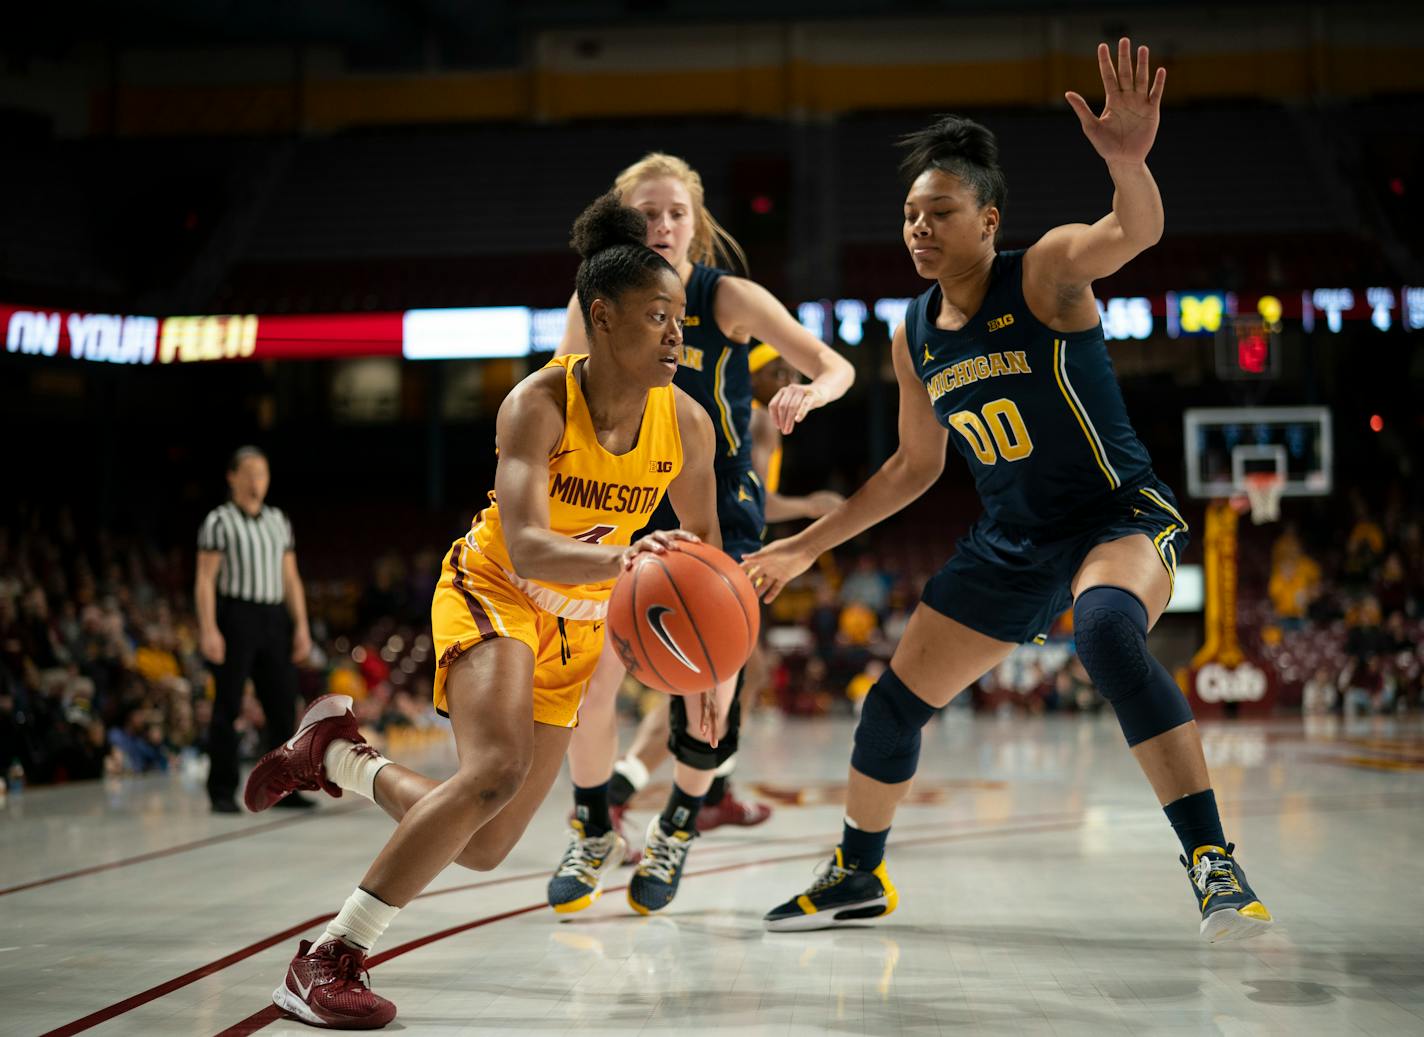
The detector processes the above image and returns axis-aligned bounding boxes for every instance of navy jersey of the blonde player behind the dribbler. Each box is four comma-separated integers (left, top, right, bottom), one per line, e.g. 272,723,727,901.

674,264,752,471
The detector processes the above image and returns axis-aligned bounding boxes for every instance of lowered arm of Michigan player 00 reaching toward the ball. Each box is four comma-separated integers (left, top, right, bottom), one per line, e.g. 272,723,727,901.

742,325,948,601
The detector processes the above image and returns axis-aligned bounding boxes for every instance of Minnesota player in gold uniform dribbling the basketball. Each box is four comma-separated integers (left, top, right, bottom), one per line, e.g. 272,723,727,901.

246,195,721,1028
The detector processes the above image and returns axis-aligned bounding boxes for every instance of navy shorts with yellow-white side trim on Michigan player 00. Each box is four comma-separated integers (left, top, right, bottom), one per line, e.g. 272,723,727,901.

920,479,1190,644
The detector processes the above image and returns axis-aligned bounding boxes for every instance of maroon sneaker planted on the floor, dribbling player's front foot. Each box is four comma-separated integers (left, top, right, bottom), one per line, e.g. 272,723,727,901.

272,940,396,1030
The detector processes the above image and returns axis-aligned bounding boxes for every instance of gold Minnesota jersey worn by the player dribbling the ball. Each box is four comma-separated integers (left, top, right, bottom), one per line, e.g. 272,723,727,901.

466,353,682,620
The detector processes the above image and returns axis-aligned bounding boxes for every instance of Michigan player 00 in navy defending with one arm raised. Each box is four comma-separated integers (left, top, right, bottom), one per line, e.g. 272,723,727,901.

743,40,1272,942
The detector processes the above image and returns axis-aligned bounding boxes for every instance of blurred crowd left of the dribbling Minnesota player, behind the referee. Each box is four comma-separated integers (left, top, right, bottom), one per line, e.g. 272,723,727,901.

0,511,436,783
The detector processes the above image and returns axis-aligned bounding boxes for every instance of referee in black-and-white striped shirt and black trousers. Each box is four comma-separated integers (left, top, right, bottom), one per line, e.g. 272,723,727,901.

194,446,312,813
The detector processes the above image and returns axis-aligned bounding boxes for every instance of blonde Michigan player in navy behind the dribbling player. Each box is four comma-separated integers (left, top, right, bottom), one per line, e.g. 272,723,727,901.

548,152,854,913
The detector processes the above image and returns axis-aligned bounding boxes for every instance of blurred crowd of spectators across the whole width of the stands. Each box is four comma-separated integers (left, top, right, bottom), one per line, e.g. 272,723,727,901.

0,481,1424,783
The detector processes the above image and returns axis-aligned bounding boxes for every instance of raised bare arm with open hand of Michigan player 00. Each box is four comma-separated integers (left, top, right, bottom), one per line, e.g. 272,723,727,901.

1024,37,1166,293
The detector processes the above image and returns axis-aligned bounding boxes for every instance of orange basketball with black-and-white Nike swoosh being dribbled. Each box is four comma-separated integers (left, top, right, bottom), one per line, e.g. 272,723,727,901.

608,541,760,695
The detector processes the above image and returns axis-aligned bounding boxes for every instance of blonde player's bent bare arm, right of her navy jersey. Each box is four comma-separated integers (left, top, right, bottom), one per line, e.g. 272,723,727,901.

716,276,856,433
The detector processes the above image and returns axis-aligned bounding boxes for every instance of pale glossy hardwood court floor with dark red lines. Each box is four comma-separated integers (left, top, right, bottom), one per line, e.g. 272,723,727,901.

0,711,1424,1037
